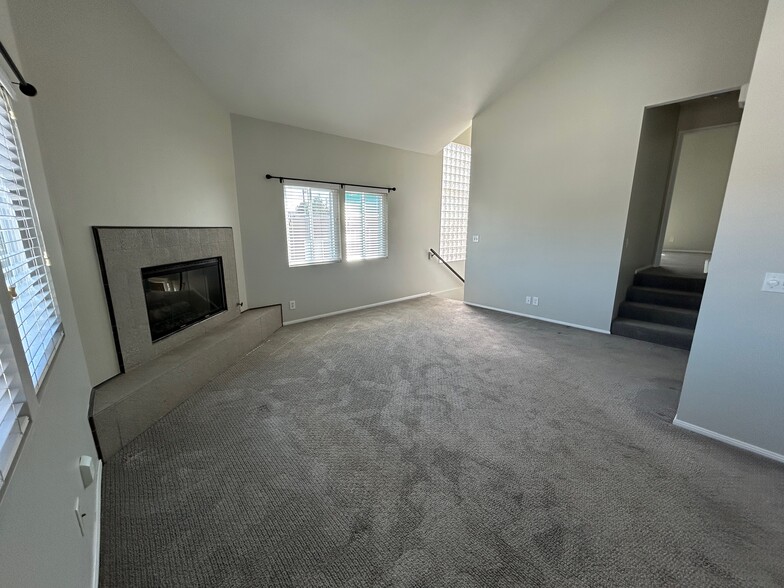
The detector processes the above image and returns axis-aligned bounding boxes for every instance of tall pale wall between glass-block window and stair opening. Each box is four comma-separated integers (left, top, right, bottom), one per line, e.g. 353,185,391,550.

465,0,765,330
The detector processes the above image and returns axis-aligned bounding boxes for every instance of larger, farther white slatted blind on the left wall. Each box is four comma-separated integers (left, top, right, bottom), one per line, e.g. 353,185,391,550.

0,89,62,389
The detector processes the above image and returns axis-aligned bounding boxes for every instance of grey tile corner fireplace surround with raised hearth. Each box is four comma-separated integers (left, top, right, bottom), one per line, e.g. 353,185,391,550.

90,227,282,459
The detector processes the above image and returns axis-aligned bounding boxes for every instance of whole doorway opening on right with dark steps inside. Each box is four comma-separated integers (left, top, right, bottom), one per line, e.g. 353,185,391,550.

611,90,743,349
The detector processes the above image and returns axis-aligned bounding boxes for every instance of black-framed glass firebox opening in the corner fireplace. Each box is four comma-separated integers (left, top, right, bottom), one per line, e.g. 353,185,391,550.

142,257,226,342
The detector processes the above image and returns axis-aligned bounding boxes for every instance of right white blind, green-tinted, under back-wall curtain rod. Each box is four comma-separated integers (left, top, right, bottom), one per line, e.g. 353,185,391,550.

344,190,387,261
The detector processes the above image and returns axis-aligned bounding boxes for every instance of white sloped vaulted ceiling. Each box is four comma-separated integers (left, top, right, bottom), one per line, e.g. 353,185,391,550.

132,0,614,153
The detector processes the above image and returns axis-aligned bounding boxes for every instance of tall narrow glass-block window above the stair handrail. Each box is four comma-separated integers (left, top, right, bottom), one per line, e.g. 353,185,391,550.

440,143,471,261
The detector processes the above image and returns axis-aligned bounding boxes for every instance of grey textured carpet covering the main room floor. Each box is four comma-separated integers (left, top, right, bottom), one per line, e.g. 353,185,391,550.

101,297,784,588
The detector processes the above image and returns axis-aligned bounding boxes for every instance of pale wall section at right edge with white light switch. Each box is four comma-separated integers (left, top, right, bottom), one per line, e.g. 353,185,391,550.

677,2,784,459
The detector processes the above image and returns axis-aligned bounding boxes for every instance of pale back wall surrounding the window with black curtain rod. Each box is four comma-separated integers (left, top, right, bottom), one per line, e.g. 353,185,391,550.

231,115,460,321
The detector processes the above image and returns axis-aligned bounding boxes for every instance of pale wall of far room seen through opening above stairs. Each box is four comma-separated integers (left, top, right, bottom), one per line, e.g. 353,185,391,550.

664,125,738,252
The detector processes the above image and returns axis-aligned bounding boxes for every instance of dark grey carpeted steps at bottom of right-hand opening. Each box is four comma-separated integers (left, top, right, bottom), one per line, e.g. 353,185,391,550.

611,268,705,349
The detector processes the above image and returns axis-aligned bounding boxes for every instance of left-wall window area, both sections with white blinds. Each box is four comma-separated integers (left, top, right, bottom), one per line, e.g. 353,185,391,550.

0,85,62,487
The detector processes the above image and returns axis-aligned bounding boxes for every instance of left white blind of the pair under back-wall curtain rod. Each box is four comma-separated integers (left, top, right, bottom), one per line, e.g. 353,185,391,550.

283,184,340,267
